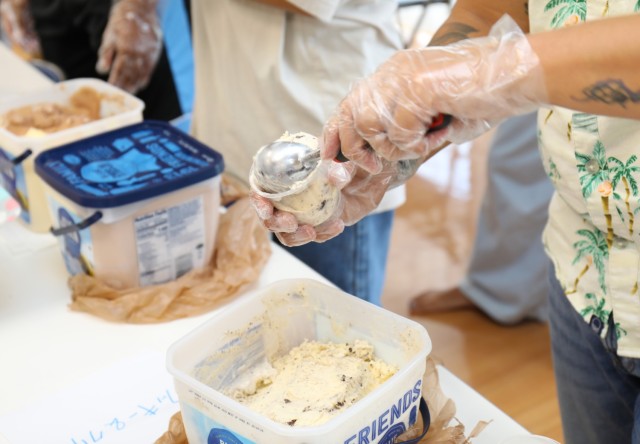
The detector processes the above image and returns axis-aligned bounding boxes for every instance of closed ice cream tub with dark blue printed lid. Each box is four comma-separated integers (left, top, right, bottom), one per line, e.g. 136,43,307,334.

35,121,224,289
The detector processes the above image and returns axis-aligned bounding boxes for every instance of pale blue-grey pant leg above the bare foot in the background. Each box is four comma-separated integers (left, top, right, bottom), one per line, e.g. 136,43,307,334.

460,113,553,324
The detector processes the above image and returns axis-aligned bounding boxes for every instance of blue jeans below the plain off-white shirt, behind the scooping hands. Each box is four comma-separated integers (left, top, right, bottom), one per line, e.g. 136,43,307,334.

285,211,394,305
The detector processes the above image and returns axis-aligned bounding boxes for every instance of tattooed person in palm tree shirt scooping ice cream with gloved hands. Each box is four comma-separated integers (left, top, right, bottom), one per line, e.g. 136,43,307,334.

253,0,640,444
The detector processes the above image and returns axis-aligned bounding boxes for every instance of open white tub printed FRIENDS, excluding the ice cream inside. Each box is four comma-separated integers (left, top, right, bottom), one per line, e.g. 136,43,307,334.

167,279,431,444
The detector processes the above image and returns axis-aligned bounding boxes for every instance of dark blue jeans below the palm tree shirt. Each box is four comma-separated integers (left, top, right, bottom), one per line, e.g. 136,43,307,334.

549,269,640,444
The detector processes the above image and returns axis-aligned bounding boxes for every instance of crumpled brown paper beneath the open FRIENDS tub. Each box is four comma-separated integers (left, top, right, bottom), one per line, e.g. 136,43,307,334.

154,357,488,444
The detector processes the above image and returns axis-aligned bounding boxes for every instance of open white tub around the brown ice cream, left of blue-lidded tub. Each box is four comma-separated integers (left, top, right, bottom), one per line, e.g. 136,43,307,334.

0,79,144,232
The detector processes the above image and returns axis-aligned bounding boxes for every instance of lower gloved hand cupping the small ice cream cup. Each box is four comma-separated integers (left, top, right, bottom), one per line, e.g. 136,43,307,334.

250,156,404,246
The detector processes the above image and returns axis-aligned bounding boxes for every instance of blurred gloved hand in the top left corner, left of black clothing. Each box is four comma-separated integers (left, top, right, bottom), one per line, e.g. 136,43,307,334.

0,0,41,59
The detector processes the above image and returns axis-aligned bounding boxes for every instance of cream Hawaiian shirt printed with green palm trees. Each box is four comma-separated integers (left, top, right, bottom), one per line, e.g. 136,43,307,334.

529,0,640,358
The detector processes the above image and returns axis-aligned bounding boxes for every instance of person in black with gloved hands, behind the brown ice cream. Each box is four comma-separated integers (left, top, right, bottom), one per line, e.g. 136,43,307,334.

0,0,182,121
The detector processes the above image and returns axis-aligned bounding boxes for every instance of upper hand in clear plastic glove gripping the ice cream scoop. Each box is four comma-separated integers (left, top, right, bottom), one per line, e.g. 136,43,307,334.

321,16,547,174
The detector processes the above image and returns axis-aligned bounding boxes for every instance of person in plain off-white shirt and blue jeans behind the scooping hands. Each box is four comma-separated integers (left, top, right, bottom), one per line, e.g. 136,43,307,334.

191,0,404,304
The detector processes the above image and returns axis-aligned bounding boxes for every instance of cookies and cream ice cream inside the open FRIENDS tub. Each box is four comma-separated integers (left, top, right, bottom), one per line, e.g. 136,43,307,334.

228,340,398,427
